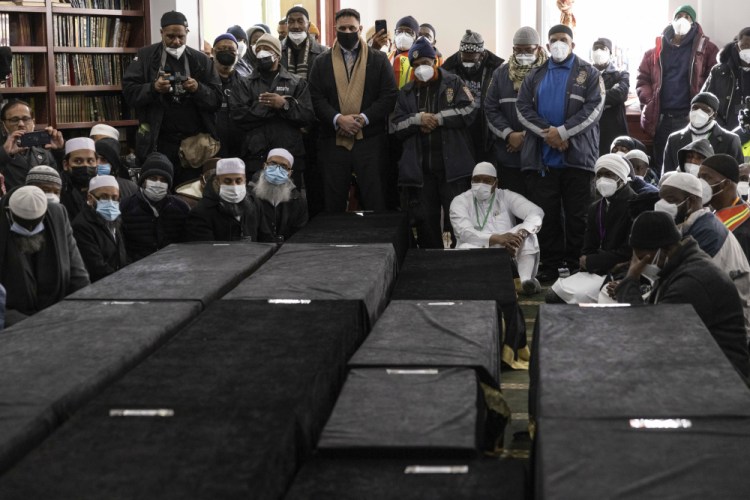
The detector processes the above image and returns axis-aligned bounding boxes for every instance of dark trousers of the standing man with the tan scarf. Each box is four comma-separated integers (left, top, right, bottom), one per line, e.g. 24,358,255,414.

318,134,388,212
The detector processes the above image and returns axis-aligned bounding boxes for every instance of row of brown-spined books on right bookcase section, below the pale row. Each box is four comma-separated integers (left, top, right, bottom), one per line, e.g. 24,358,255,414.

55,54,134,85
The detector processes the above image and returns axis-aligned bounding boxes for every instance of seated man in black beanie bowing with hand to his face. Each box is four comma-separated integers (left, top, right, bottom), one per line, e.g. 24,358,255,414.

615,212,750,380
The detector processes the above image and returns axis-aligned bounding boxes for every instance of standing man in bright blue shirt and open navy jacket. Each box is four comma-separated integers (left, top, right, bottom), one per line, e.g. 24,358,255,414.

516,24,605,281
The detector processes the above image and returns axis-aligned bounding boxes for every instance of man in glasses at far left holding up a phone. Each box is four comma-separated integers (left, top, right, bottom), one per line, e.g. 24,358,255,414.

0,100,65,190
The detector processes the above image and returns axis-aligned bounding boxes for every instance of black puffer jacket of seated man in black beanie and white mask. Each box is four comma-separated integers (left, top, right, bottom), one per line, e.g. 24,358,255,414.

120,189,190,262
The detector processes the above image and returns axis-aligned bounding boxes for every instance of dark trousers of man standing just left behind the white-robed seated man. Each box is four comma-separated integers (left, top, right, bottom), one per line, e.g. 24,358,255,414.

413,171,471,248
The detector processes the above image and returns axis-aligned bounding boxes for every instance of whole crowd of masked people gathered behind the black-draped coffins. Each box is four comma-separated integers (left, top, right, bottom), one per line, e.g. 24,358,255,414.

0,5,750,376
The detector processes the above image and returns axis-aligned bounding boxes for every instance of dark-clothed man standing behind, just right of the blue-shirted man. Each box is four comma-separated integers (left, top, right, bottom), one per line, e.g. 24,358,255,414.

592,38,630,156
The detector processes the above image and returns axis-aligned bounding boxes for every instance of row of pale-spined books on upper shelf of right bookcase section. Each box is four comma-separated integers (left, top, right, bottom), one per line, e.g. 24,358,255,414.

52,15,132,47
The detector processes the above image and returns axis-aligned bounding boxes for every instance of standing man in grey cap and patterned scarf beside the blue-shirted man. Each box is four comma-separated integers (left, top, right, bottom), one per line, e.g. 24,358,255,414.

484,26,547,195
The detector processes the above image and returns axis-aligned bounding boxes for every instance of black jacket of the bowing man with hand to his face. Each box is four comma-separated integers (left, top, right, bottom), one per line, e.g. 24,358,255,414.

617,237,750,379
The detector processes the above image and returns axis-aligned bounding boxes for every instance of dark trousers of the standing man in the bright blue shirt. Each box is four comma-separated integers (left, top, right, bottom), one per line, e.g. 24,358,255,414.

526,168,594,270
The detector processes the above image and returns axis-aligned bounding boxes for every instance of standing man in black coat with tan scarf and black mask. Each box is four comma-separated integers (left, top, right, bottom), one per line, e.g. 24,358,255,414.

309,9,397,212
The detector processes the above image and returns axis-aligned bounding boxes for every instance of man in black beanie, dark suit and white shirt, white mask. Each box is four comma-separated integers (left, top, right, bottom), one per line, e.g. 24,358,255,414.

662,92,744,175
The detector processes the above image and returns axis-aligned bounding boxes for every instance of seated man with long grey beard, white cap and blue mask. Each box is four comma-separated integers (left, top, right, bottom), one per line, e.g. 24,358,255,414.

250,148,307,243
